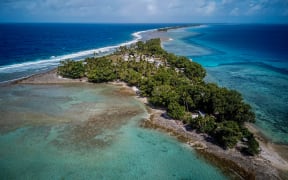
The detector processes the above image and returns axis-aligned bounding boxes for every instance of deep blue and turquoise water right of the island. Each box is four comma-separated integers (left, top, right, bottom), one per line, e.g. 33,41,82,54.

163,24,288,145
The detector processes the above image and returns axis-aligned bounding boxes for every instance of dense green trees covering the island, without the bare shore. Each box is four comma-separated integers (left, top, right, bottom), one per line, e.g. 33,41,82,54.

58,39,259,155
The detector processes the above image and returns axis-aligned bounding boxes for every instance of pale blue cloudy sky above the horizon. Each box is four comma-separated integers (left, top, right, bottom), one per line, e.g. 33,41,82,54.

0,0,288,23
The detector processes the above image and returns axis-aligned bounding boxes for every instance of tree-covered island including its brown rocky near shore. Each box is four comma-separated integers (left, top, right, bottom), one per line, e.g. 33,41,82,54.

57,38,286,179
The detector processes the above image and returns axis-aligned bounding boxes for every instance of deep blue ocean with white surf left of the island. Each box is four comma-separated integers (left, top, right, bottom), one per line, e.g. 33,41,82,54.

0,23,177,82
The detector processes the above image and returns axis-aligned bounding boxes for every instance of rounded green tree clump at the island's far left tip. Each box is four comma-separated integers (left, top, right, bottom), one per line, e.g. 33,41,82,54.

57,59,85,79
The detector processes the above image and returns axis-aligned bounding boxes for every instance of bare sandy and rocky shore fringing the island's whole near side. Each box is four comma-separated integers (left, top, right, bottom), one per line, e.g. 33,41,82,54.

11,69,288,179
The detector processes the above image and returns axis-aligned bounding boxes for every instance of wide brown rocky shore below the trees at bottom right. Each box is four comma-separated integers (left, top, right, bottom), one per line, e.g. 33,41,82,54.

142,107,288,179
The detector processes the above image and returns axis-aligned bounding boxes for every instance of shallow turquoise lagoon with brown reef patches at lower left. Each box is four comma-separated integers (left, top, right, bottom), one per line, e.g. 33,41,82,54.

0,84,227,180
